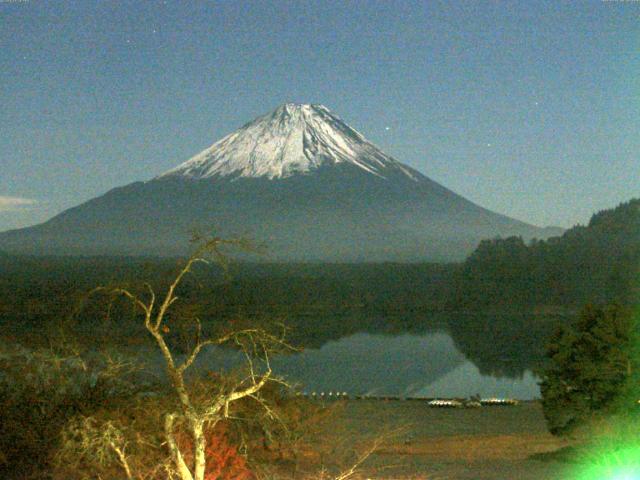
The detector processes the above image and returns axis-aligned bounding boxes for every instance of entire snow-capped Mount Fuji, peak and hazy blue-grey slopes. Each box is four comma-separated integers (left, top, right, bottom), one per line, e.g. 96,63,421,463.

0,104,560,261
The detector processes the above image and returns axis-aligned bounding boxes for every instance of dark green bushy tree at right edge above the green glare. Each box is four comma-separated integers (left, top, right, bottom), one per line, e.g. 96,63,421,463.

540,306,636,434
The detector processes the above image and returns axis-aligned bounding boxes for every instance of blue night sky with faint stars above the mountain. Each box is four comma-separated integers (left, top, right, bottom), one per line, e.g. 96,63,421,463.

0,0,640,230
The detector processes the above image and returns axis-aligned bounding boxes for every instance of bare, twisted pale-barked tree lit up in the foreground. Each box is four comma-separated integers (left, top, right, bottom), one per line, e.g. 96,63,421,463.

87,238,290,480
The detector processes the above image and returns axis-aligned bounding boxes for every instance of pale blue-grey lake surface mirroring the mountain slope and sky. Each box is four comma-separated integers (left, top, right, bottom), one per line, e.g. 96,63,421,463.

199,332,540,400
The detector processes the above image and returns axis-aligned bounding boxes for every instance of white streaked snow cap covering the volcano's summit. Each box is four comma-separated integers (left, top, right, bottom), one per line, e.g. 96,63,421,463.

158,103,419,180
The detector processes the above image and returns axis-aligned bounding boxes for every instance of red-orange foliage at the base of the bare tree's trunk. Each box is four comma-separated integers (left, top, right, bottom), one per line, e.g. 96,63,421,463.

176,424,255,480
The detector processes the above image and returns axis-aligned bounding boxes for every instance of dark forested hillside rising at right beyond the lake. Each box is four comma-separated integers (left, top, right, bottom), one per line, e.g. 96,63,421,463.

449,199,640,309
